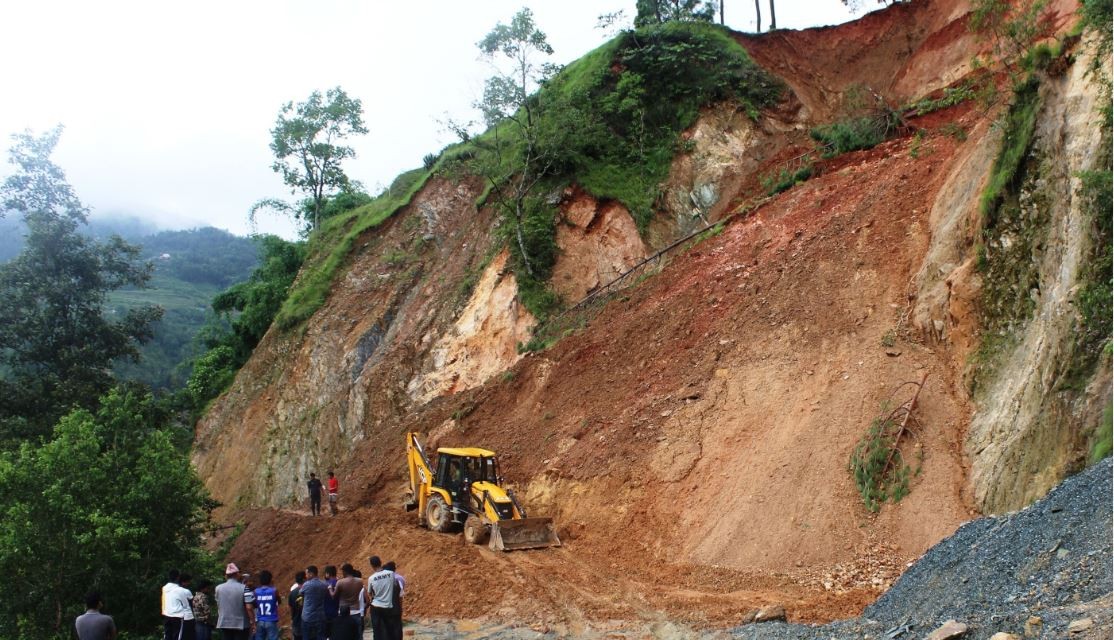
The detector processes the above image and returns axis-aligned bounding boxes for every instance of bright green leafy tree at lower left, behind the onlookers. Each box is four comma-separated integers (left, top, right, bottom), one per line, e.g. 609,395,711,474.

0,390,213,640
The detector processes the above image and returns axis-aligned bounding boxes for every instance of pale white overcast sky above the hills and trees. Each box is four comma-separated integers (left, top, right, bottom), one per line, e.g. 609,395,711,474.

0,0,873,237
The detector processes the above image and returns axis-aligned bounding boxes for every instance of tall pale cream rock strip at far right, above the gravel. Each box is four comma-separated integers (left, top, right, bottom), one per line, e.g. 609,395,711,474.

967,40,1111,513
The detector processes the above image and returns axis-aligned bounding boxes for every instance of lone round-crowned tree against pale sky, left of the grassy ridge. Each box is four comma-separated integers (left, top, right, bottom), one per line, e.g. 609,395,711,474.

251,87,368,230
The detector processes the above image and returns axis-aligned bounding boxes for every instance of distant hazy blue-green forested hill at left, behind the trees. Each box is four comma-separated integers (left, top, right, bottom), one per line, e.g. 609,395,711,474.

0,216,258,388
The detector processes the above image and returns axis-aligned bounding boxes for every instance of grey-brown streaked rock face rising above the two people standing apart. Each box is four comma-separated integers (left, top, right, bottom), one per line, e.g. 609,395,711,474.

194,179,503,506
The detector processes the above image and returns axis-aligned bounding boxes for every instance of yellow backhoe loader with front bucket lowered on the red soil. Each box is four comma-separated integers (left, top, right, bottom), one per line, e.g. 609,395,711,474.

407,433,560,551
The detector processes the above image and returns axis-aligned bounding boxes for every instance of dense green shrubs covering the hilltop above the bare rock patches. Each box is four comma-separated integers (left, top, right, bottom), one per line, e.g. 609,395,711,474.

537,22,783,230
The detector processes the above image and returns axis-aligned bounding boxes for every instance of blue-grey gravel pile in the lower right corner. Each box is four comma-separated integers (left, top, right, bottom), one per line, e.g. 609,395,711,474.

732,460,1112,640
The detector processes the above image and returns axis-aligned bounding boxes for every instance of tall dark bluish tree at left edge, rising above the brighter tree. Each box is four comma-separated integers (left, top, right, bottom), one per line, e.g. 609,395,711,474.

0,127,162,442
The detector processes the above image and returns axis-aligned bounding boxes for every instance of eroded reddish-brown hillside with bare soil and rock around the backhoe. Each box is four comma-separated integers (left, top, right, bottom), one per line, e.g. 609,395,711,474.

194,0,1110,632
